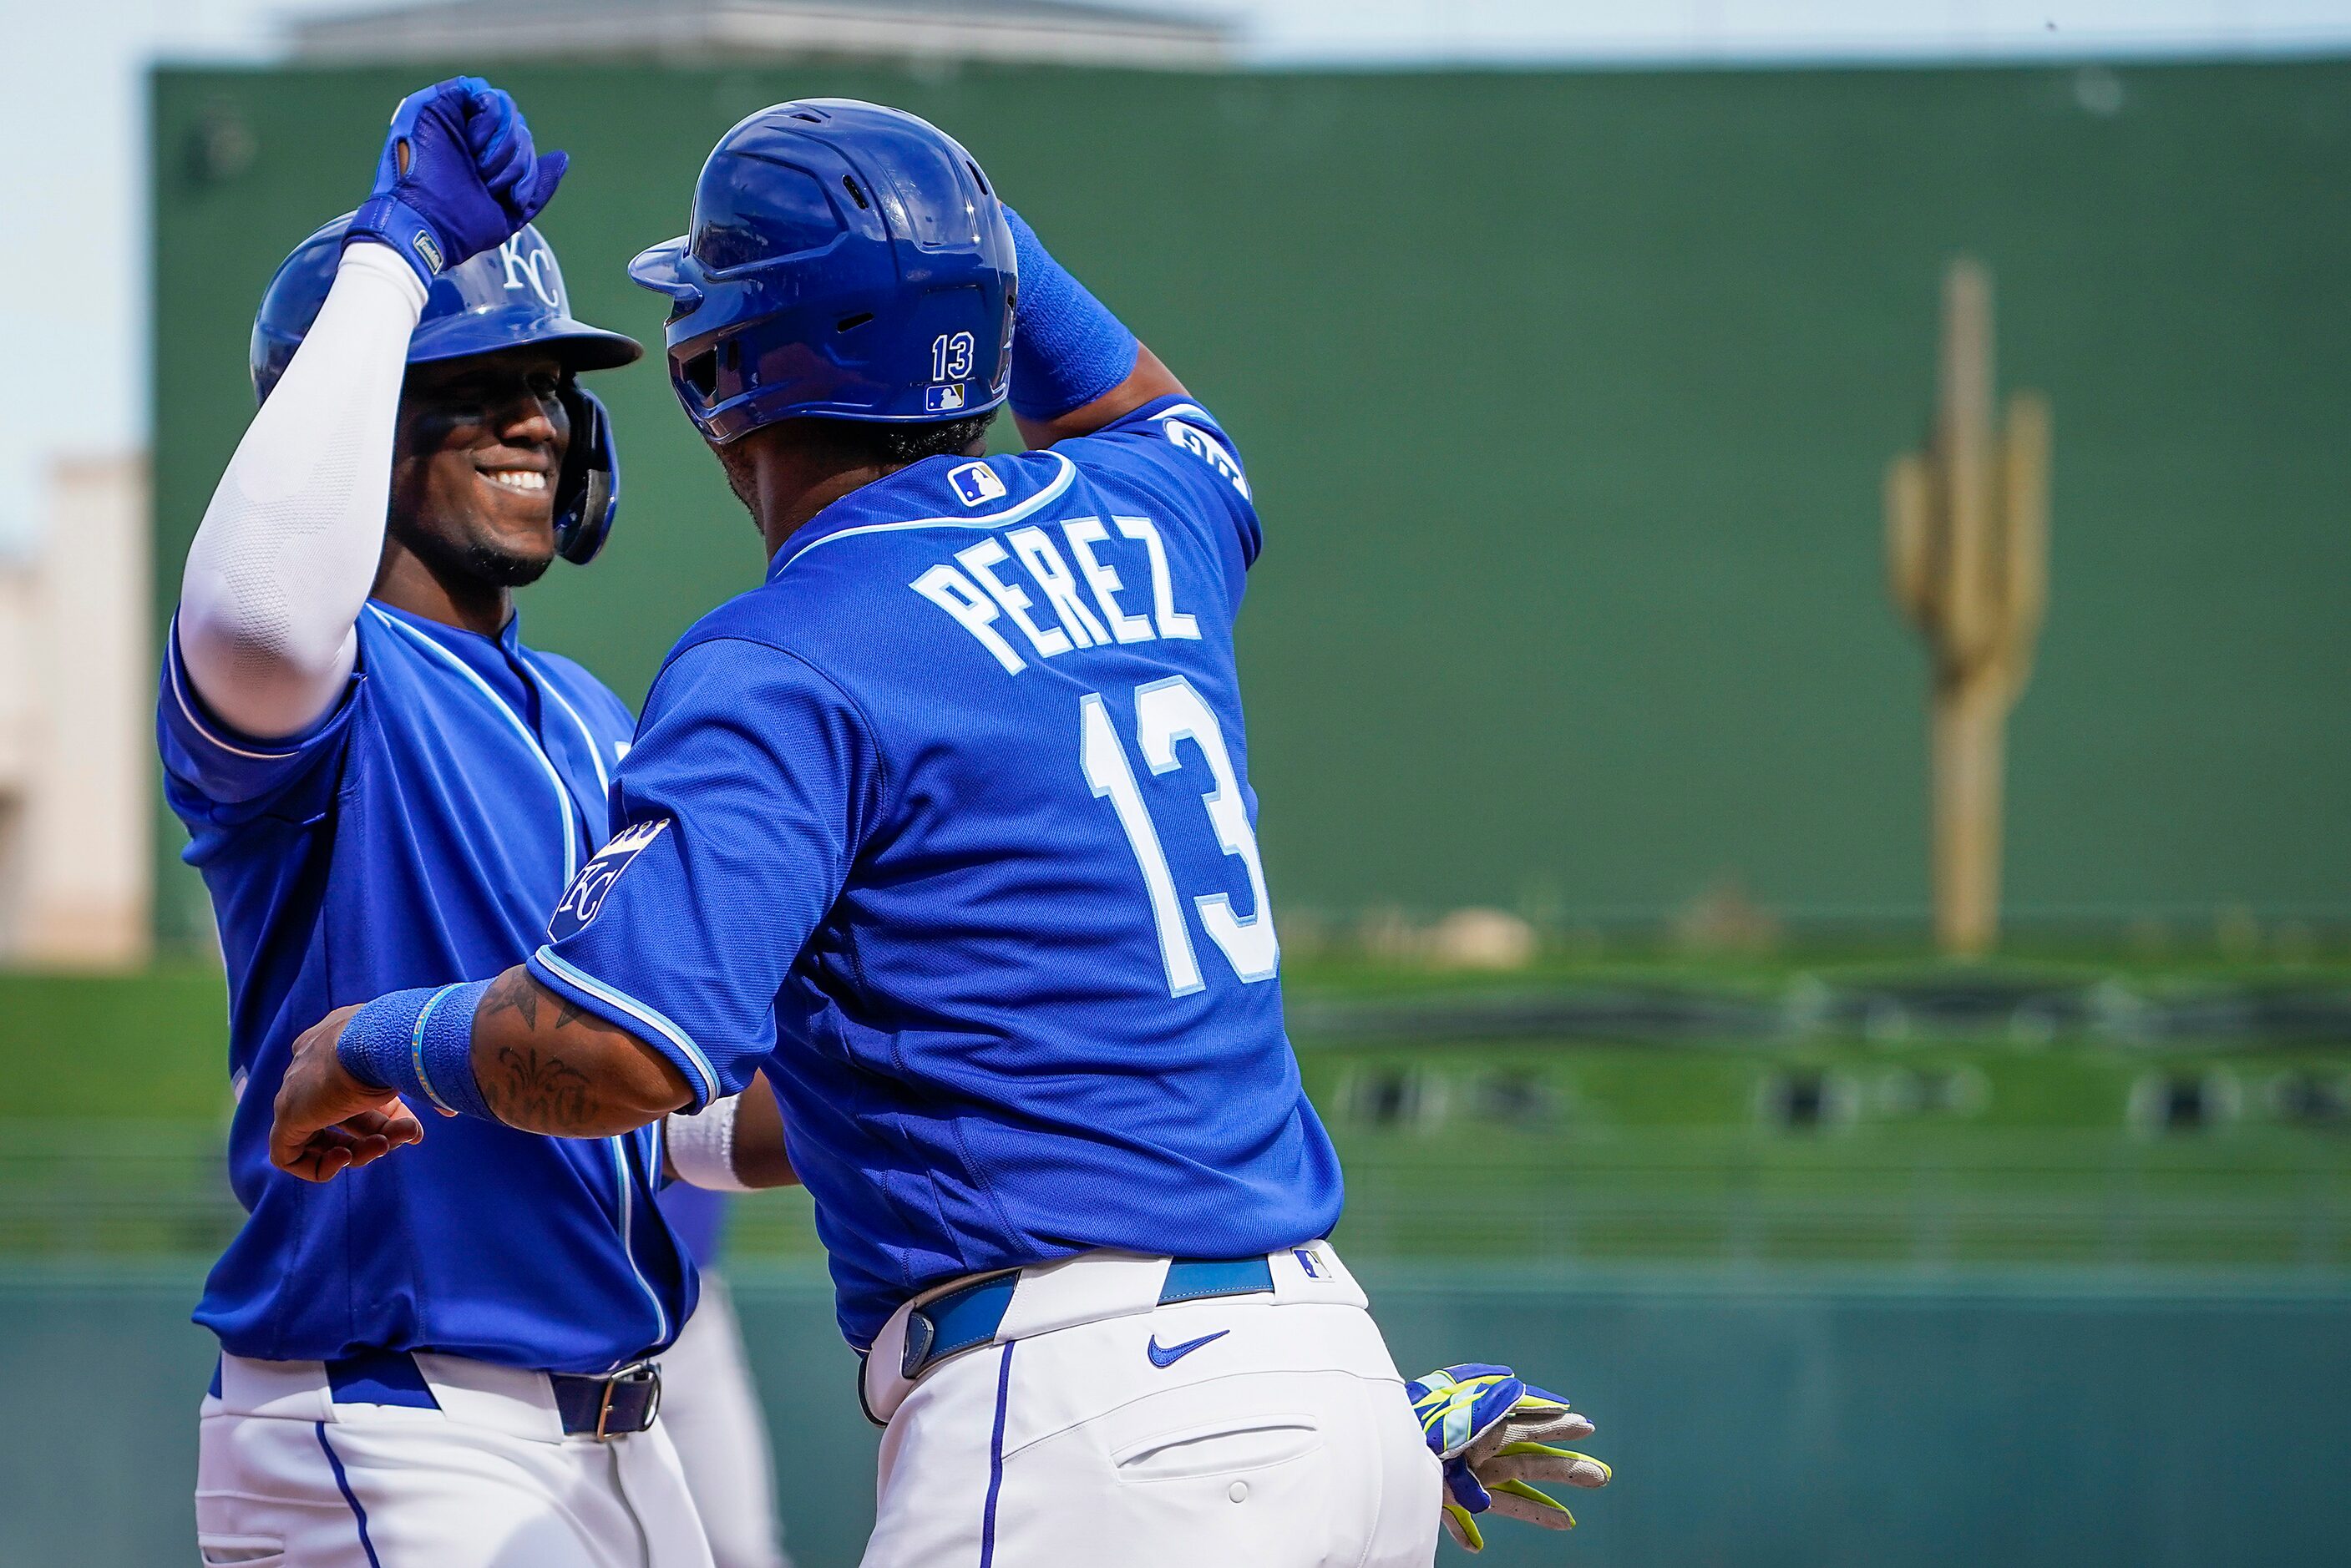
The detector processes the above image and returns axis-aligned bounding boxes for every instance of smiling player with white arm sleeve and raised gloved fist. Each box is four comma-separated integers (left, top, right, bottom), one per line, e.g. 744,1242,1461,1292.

158,78,728,1568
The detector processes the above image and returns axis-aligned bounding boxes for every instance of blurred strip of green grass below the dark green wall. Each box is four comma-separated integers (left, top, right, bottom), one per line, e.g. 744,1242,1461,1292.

13,966,2351,1286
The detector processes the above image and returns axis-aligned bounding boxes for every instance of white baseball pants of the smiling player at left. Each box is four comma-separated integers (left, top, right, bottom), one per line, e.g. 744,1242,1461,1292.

195,1354,710,1568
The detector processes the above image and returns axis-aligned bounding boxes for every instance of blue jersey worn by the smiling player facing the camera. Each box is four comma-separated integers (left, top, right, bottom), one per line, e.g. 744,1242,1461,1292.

158,604,696,1370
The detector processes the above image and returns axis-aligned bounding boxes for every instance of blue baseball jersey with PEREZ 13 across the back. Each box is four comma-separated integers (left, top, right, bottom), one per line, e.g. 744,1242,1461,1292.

531,400,1340,1347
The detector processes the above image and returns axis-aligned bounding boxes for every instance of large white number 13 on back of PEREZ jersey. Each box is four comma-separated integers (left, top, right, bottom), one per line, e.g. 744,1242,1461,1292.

1079,675,1281,997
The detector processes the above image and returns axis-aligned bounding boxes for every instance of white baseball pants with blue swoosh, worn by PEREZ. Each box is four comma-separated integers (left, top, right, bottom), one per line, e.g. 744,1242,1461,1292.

865,1243,1442,1568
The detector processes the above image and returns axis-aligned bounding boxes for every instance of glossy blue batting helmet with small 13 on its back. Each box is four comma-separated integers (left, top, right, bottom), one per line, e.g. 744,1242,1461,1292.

628,99,1018,442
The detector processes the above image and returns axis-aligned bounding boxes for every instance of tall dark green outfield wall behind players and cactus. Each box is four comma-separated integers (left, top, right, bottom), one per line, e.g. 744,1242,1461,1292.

153,63,2351,944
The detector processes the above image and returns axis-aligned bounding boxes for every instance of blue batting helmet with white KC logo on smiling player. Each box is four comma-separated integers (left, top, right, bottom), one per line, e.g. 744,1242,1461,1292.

249,211,644,564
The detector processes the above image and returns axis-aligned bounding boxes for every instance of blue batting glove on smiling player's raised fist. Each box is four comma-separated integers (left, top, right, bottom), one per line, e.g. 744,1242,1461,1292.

343,75,571,289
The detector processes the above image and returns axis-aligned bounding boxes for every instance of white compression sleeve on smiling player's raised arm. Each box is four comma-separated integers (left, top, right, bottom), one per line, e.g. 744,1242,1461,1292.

179,245,426,738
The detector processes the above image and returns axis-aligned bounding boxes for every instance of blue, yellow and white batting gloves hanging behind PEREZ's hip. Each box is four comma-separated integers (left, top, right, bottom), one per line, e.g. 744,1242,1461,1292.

1404,1361,1610,1551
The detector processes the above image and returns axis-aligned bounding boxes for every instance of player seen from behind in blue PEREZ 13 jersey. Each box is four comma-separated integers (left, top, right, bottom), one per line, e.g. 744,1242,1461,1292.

273,99,1606,1568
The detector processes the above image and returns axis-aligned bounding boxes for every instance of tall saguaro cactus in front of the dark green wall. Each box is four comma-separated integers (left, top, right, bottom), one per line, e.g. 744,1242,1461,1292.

1886,259,2050,954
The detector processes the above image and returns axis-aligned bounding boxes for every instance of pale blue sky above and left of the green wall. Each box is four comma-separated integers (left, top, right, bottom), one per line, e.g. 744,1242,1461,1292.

0,0,2351,550
